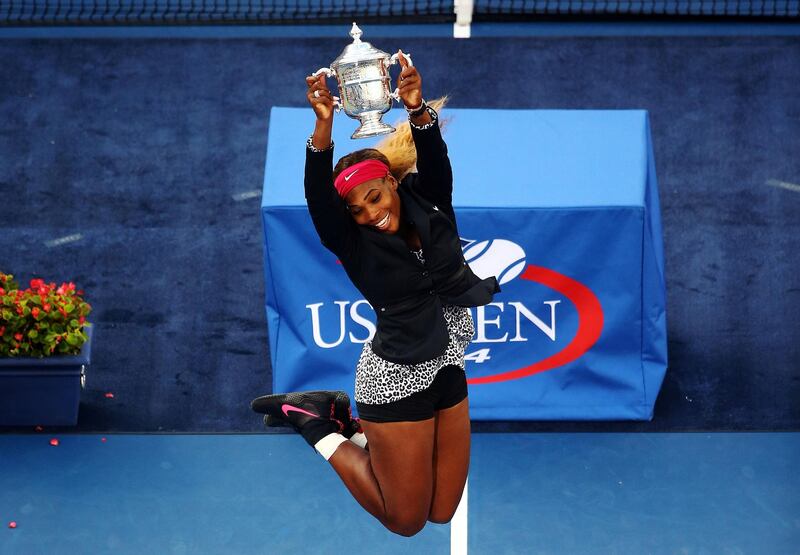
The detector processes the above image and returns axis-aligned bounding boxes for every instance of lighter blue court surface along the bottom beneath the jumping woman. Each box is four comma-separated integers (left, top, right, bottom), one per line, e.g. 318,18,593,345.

0,432,800,555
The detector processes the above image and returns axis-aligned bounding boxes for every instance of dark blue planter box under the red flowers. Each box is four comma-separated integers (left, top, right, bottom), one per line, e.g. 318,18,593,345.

0,325,93,426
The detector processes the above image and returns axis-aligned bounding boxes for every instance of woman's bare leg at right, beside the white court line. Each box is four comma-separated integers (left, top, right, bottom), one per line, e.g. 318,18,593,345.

428,399,470,524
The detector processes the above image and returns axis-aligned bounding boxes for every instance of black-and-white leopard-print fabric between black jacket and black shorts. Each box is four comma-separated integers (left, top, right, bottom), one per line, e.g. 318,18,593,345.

355,305,475,405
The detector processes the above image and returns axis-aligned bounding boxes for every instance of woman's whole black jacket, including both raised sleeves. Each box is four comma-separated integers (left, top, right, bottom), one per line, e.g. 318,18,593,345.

305,111,500,364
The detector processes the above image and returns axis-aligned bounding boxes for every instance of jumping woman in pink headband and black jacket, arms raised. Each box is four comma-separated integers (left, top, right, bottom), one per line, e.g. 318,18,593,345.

252,53,499,536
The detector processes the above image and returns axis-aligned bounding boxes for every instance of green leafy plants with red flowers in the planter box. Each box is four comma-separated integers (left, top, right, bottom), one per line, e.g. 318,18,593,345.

0,272,92,357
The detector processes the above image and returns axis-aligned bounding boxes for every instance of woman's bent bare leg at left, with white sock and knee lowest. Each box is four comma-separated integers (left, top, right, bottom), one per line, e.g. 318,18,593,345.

329,418,438,536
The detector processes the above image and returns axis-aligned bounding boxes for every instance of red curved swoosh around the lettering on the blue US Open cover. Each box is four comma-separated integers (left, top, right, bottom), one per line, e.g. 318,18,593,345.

467,264,603,385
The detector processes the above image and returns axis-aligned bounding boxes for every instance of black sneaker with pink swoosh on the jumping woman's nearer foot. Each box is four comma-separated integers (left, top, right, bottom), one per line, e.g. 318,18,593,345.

250,391,347,447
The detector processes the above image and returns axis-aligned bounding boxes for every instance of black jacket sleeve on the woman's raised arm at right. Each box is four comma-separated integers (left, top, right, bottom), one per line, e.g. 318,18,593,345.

411,108,453,211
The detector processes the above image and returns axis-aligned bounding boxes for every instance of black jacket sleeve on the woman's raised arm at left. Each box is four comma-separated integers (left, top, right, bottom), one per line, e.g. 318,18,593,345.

304,146,357,260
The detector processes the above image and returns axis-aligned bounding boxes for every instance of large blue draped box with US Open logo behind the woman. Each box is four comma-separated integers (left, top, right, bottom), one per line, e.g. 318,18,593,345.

262,108,667,420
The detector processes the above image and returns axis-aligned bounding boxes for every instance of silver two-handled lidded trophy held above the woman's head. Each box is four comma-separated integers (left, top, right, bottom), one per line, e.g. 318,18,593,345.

314,23,413,139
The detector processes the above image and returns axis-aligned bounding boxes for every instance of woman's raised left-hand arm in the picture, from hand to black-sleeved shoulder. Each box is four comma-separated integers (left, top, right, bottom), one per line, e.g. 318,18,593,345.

304,75,356,259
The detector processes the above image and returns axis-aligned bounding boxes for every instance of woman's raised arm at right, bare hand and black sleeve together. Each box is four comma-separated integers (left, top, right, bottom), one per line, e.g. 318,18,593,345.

397,53,453,207
